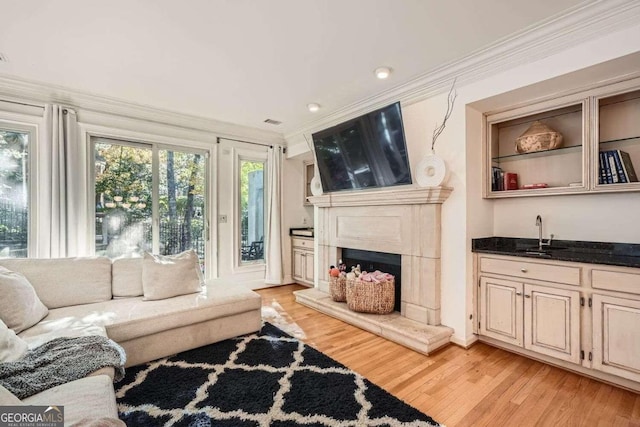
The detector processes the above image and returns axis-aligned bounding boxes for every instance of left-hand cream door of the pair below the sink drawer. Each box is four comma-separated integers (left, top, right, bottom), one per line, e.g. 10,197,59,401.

480,277,523,347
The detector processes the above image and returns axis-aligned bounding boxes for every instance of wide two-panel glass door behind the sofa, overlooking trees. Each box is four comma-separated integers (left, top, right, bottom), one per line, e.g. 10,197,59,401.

94,138,208,265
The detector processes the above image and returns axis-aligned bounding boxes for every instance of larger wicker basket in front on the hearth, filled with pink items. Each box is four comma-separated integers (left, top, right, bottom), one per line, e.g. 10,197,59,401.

347,279,395,314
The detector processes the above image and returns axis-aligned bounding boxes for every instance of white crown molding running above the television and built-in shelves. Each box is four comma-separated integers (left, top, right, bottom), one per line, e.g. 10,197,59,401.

285,0,640,145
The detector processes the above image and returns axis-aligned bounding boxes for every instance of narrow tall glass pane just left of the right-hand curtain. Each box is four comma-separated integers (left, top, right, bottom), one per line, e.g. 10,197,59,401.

239,159,265,264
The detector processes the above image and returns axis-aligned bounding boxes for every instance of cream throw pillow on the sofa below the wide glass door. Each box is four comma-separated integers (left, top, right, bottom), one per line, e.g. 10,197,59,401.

142,250,203,300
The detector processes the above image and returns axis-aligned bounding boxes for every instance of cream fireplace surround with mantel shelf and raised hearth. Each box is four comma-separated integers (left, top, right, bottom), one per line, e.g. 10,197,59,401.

296,186,453,352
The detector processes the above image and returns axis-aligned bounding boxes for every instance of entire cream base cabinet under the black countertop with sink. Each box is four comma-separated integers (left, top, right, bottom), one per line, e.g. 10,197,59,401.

474,253,640,392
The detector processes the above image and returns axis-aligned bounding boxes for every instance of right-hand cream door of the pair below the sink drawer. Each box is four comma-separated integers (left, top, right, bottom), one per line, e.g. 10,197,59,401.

524,284,580,363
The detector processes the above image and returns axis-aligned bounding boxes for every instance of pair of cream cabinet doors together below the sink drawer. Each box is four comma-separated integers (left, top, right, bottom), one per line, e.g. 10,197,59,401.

479,277,580,363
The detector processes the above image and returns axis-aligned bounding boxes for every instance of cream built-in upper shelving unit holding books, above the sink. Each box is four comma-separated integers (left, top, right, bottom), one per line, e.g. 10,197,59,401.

483,78,640,198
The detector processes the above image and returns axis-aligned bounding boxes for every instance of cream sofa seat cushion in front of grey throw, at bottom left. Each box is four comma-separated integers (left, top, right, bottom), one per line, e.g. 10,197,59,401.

22,375,118,425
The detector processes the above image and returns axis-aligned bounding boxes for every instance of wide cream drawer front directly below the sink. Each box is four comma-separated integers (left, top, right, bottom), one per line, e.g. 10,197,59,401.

480,257,580,286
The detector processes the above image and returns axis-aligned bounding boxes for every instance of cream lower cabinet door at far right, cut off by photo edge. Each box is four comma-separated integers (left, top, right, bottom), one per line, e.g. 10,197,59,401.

593,294,640,381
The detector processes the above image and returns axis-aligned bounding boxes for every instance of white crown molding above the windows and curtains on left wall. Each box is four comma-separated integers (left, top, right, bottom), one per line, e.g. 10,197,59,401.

0,74,284,144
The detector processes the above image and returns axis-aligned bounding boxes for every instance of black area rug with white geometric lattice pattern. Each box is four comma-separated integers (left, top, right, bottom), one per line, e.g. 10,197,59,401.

116,323,439,427
